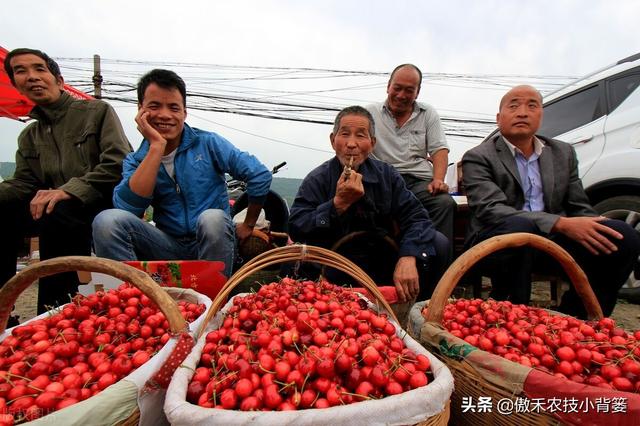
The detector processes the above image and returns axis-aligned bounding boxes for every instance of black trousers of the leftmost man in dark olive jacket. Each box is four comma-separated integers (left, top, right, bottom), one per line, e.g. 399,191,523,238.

0,199,101,314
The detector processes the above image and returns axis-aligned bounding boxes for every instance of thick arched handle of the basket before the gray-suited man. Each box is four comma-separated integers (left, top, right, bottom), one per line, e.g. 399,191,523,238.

426,232,604,324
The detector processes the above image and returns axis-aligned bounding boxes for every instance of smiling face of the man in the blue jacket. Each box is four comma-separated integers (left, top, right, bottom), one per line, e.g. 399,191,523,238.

138,83,187,145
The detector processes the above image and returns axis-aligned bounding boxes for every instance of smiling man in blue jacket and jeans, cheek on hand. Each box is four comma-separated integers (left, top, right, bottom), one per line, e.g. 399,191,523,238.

93,69,271,276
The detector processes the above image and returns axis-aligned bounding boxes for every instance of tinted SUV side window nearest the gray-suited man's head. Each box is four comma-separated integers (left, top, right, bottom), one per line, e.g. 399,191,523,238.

538,85,604,138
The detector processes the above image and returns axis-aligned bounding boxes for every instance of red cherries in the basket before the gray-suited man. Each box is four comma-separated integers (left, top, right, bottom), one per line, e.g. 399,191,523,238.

424,299,640,392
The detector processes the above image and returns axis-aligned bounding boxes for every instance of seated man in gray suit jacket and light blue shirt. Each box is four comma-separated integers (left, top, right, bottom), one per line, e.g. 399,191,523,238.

462,86,640,317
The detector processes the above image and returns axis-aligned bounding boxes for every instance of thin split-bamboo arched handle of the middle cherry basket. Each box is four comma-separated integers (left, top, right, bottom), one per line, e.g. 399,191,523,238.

198,244,398,337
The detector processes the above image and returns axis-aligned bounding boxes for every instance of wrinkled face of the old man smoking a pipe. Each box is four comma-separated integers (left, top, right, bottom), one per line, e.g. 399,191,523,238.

329,115,376,170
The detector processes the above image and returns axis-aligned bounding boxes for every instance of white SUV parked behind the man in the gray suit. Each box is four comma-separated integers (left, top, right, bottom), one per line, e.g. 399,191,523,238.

538,53,640,287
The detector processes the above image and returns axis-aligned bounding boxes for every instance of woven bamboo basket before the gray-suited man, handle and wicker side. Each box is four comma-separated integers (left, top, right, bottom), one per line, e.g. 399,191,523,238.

420,233,603,426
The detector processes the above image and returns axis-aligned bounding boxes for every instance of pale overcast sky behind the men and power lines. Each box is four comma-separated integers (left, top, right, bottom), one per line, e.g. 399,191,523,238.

0,0,640,178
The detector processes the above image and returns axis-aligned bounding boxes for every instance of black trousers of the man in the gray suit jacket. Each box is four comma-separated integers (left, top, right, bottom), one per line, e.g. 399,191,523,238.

475,216,640,318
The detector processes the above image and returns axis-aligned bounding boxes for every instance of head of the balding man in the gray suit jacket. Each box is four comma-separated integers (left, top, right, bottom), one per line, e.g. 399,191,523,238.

496,86,542,140
